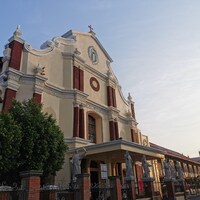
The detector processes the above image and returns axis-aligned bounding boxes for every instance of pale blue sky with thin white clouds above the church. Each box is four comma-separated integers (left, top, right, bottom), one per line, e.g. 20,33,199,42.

0,0,200,157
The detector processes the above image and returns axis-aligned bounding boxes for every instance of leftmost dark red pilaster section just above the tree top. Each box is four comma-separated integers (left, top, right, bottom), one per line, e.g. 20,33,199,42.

2,88,17,112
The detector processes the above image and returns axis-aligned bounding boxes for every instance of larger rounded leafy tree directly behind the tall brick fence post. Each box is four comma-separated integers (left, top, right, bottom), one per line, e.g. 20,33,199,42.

0,99,67,181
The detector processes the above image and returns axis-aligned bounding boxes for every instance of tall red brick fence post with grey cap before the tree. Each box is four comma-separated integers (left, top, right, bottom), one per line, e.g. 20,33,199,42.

20,170,42,200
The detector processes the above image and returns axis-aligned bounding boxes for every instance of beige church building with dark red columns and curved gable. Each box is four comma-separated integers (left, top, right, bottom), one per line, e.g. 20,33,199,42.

0,26,200,196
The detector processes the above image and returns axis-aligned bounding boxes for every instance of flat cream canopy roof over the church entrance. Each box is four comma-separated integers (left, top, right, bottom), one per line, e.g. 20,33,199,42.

68,139,164,162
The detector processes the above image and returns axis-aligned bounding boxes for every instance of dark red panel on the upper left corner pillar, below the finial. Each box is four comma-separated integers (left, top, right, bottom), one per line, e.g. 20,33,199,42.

9,40,23,70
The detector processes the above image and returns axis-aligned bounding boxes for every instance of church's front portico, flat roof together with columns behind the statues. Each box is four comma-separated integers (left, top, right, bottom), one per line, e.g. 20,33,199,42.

68,138,164,190
